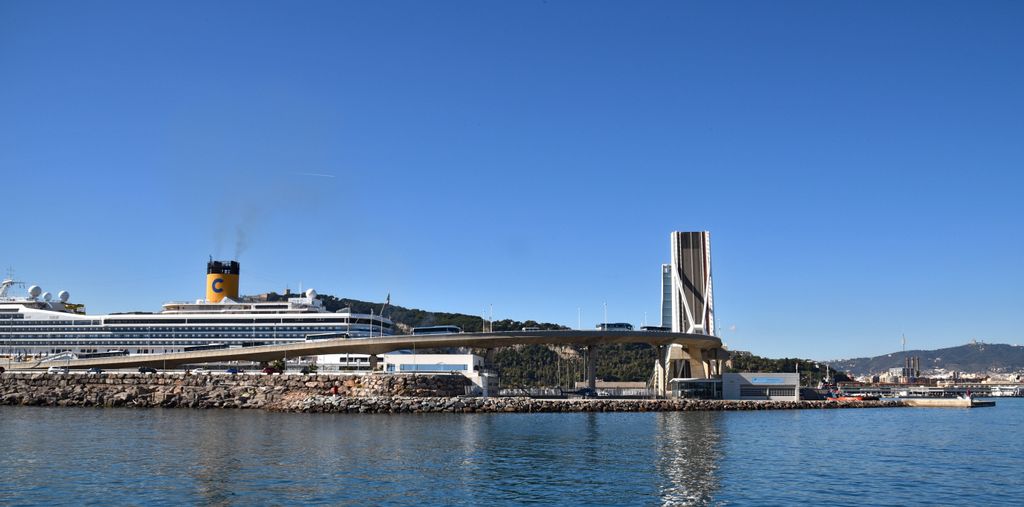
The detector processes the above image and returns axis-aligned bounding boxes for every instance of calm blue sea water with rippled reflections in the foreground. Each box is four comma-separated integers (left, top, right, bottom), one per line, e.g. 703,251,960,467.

0,399,1024,505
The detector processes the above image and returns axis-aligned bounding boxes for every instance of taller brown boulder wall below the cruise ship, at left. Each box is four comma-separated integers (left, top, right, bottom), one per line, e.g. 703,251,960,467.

0,372,469,410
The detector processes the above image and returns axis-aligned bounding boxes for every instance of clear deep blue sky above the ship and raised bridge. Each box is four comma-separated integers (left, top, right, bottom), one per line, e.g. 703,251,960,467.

0,0,1024,358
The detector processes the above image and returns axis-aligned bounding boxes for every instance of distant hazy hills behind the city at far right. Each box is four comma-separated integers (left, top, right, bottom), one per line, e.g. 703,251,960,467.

826,342,1024,375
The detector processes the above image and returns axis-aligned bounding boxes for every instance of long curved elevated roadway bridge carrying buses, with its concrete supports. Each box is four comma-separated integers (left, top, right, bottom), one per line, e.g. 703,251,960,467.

11,331,728,390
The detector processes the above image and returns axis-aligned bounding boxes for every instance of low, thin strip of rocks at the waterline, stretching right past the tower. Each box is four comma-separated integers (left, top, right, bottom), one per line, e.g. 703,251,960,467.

288,395,903,414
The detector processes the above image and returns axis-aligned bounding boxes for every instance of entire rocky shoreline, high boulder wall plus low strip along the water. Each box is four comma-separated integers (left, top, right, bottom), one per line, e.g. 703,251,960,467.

0,372,906,414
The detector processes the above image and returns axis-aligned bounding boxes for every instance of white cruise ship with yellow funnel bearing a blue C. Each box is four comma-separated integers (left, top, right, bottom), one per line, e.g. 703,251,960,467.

0,259,393,357
